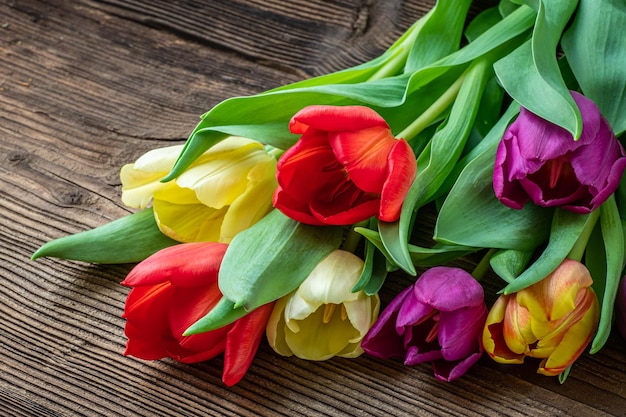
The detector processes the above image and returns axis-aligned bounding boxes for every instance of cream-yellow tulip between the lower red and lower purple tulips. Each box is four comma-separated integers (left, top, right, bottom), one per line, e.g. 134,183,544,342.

266,250,380,361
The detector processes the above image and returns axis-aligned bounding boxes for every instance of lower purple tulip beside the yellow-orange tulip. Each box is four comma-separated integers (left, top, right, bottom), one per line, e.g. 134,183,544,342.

361,267,487,381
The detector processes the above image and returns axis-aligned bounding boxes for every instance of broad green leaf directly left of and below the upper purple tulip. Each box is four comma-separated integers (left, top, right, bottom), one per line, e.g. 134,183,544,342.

434,138,552,251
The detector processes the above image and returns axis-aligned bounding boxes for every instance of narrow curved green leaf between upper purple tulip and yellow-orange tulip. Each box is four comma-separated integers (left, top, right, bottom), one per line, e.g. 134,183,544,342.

502,209,597,294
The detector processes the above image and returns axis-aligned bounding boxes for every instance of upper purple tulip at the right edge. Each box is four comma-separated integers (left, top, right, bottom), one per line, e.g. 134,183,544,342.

493,91,626,214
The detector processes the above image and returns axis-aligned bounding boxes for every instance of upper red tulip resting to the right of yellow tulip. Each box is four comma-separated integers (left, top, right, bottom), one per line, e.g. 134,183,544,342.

274,106,417,225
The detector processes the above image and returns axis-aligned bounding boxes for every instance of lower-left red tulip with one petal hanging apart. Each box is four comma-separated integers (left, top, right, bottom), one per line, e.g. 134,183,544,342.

122,242,272,386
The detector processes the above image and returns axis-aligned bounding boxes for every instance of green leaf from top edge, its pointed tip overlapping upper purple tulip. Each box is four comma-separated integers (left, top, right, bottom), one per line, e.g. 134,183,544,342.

494,0,582,139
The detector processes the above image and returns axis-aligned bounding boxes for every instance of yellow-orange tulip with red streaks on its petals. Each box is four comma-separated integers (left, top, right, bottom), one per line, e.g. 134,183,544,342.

483,259,600,376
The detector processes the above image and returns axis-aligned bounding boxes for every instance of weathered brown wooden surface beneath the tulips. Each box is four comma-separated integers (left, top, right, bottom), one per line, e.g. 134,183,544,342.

0,0,626,416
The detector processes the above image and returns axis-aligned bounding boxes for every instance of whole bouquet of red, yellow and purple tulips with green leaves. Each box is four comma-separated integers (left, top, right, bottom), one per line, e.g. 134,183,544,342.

33,0,626,385
